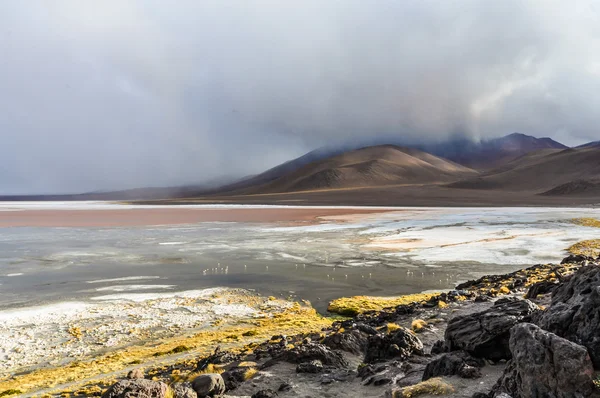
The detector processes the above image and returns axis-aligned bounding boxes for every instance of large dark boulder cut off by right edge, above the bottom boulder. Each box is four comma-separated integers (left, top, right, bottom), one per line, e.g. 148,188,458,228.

534,265,600,369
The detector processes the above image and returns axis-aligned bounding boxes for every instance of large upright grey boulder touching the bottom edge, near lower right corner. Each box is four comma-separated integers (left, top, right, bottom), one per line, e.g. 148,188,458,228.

492,323,600,398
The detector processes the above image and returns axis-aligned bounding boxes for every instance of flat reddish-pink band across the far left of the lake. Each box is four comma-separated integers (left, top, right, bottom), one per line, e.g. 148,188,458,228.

0,207,391,227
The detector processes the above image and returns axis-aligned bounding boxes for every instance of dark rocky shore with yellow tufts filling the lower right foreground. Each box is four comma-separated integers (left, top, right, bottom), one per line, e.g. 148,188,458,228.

5,255,600,398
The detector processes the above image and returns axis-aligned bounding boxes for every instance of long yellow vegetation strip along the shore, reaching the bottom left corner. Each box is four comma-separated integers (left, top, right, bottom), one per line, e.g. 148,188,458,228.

0,303,332,393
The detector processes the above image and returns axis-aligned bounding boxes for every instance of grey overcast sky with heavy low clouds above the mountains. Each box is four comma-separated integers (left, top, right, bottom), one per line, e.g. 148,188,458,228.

0,0,600,193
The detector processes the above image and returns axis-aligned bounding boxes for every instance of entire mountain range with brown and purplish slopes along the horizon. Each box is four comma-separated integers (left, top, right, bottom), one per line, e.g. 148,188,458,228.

0,133,600,205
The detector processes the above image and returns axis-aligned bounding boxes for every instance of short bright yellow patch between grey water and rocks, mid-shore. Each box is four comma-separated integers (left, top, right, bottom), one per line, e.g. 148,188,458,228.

327,293,439,316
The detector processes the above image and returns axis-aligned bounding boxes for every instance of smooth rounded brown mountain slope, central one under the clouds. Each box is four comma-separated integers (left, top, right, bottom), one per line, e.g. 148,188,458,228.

244,145,477,193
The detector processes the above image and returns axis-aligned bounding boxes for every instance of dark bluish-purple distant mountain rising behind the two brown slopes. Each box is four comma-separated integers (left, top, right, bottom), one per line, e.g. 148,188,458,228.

419,133,568,170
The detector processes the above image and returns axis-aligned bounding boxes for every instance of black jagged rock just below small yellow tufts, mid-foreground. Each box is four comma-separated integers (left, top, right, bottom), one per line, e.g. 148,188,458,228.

365,327,423,363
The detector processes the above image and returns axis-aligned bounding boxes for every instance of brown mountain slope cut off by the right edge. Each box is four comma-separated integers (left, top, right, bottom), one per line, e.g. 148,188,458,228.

449,148,600,193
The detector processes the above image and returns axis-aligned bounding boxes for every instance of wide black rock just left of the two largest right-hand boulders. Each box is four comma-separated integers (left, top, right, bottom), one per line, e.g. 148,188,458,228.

444,298,538,361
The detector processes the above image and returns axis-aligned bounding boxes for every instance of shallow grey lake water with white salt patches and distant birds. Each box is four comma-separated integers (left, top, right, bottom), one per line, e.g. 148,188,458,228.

0,205,600,311
